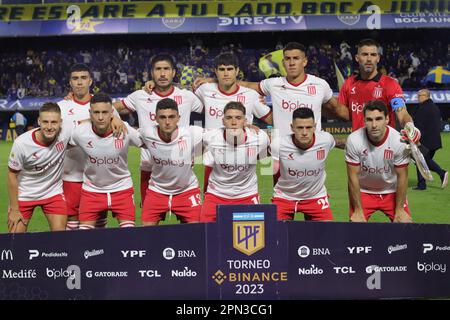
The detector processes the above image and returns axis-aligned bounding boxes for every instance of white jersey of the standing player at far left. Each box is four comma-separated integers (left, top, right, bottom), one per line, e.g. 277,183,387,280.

58,100,91,182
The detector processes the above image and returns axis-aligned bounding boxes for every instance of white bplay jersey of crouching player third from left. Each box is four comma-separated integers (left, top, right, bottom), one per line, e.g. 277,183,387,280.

141,126,203,195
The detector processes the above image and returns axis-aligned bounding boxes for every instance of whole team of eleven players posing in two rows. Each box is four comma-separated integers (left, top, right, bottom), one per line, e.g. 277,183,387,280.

8,40,428,232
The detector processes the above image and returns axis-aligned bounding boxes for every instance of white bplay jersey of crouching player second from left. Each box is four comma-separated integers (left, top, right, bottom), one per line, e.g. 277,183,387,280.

70,122,142,193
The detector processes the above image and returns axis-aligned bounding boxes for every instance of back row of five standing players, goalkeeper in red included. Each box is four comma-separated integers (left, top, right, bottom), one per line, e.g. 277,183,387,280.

6,40,420,229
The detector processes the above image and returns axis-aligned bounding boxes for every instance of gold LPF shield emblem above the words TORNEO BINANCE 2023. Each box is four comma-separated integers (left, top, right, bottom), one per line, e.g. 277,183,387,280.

233,212,265,256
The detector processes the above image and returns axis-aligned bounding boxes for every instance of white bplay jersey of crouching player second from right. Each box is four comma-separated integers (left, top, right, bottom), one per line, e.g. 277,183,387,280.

271,131,335,200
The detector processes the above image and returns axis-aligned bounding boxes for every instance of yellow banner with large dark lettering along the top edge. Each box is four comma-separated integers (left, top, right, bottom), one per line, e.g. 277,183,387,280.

0,0,450,21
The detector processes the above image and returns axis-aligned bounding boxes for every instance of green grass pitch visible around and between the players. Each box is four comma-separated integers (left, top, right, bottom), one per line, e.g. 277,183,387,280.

0,133,450,233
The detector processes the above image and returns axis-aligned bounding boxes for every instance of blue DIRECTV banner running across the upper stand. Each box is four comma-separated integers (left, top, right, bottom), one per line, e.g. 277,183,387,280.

0,13,450,37
